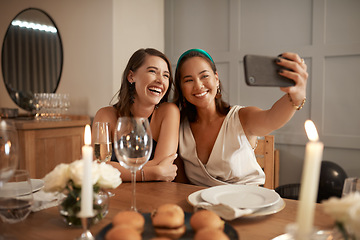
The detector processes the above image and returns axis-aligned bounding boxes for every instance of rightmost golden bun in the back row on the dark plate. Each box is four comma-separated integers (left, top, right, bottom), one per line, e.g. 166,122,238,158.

190,209,225,232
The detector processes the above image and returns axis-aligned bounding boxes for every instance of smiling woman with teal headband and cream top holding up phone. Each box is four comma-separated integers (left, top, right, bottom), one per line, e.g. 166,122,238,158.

175,49,308,186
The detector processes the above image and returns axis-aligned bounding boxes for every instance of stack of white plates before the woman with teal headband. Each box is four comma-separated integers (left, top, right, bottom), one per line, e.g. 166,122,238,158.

188,185,285,217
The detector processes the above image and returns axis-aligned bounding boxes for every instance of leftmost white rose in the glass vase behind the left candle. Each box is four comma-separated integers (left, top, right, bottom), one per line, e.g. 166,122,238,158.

44,163,70,192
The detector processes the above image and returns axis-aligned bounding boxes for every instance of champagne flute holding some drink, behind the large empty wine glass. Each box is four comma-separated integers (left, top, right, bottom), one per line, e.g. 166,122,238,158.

93,122,112,162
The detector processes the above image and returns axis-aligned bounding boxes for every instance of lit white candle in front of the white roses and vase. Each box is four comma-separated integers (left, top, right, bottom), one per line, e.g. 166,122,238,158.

79,125,94,218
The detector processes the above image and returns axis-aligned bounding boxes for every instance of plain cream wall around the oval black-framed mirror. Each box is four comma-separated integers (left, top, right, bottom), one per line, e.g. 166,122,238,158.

0,0,164,116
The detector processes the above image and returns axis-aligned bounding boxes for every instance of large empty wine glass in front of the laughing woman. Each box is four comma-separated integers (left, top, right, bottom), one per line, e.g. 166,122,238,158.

114,117,153,211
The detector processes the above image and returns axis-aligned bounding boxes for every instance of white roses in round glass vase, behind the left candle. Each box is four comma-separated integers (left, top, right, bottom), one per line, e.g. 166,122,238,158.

44,160,122,226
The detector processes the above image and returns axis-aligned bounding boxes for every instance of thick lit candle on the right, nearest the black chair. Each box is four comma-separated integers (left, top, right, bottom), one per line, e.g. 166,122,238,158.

297,120,324,239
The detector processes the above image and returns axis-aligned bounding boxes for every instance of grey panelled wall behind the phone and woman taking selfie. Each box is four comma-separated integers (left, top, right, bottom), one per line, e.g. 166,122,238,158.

165,0,360,184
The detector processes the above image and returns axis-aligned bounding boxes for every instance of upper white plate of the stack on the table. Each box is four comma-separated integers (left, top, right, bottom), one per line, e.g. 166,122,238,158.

201,185,280,209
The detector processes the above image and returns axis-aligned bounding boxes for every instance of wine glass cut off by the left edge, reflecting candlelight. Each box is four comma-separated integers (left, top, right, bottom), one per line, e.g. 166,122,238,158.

0,119,18,189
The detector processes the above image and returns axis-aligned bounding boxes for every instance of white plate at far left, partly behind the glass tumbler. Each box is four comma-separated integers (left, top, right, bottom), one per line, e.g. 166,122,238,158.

1,179,44,197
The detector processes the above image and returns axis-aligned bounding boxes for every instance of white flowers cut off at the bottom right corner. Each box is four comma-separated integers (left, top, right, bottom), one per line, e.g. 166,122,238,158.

322,192,360,240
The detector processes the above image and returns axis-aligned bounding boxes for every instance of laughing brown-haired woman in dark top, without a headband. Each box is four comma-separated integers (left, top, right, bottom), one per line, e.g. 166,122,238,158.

93,48,180,181
